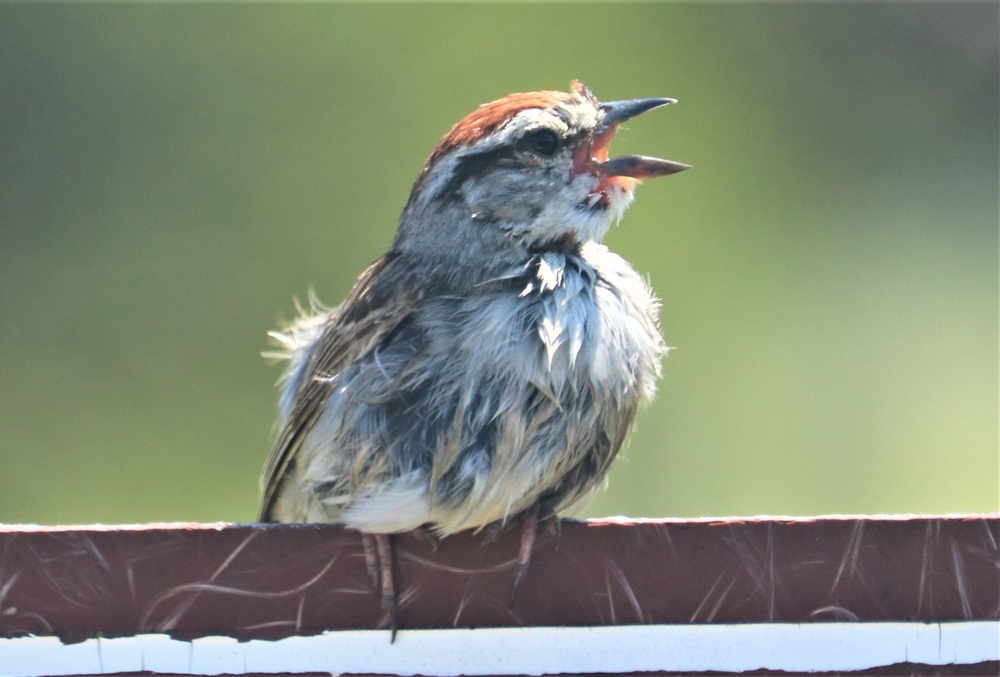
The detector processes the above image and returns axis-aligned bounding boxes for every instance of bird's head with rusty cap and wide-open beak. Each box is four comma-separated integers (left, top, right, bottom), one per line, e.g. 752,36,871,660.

396,82,688,259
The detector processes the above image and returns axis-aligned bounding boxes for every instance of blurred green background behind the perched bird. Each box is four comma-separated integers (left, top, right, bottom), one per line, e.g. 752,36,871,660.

0,3,1000,523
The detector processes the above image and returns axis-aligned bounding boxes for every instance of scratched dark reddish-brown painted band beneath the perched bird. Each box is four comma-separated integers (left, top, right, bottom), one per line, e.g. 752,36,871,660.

0,515,1000,641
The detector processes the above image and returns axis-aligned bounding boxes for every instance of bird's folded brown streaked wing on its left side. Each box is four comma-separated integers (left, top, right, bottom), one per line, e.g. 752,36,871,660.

259,252,421,522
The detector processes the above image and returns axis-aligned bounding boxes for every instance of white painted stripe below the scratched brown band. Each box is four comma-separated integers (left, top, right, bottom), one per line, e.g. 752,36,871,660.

0,621,1000,677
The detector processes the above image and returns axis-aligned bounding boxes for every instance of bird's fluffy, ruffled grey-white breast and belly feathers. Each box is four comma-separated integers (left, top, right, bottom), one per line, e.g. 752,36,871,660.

270,244,666,533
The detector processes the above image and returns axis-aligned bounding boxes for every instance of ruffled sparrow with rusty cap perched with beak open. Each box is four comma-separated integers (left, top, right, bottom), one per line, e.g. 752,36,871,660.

259,81,689,637
